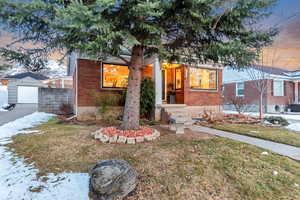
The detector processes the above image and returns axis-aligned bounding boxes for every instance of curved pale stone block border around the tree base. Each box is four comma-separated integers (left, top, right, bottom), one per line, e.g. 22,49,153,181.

92,127,160,144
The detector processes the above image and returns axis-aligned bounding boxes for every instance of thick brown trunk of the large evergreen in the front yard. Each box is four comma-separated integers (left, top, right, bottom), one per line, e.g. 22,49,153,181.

120,46,144,130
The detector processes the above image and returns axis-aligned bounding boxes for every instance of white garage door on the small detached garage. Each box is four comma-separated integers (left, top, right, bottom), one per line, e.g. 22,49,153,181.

18,86,39,103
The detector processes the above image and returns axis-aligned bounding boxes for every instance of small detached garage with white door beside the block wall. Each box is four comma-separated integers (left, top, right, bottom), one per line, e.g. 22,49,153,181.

6,72,48,104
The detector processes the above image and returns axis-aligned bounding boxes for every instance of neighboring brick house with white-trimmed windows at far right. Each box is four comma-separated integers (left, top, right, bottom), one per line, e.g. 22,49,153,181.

223,66,300,113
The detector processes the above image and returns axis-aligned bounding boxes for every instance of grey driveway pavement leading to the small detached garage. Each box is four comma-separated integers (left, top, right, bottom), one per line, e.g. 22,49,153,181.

0,104,37,126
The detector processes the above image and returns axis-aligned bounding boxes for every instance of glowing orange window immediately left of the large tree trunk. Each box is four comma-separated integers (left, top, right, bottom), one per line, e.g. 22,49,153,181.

102,64,129,88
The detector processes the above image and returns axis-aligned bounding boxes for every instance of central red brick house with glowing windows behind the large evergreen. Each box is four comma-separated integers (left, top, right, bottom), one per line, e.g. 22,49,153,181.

68,53,222,120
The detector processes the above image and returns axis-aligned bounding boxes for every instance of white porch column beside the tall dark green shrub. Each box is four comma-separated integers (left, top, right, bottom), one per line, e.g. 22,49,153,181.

153,58,162,120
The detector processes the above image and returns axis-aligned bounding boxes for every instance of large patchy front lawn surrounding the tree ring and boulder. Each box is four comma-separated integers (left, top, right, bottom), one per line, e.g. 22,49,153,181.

8,120,300,200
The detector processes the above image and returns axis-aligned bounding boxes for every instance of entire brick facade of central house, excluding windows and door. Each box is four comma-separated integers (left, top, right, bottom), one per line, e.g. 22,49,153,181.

73,59,222,119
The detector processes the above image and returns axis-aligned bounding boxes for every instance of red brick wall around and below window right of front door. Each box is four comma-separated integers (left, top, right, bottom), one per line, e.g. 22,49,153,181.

184,67,222,106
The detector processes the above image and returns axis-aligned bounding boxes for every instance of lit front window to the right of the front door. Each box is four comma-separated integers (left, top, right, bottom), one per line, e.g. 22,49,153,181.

189,68,218,90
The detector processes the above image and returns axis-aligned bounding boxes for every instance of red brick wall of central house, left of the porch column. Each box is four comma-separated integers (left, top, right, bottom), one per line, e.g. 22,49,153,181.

77,59,152,106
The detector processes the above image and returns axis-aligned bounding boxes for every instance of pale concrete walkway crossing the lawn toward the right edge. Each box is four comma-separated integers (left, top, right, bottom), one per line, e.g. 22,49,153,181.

189,126,300,161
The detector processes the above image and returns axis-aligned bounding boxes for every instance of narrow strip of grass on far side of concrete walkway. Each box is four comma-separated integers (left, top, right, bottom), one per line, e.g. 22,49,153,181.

213,123,300,147
